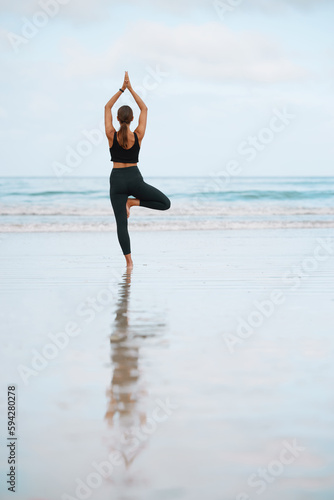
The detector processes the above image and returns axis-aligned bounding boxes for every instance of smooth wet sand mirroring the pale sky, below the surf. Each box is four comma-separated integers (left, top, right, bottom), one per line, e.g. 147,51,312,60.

0,229,334,500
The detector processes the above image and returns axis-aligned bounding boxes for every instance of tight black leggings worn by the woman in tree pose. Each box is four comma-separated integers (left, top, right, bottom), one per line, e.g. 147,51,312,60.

110,165,170,255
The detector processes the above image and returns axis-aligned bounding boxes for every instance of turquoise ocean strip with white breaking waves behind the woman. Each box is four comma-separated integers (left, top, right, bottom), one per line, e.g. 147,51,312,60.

0,174,334,232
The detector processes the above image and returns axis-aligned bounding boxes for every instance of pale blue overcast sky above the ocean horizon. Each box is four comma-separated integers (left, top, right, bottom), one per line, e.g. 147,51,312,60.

0,0,334,176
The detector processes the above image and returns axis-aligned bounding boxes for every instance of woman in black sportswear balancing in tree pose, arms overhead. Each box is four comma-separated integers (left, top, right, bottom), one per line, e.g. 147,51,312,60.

104,71,170,267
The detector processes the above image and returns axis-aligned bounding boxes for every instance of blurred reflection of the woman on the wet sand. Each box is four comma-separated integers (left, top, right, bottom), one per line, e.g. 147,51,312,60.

105,269,165,466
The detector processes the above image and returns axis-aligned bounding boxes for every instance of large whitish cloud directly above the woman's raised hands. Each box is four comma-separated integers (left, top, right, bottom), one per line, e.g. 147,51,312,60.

58,21,308,83
